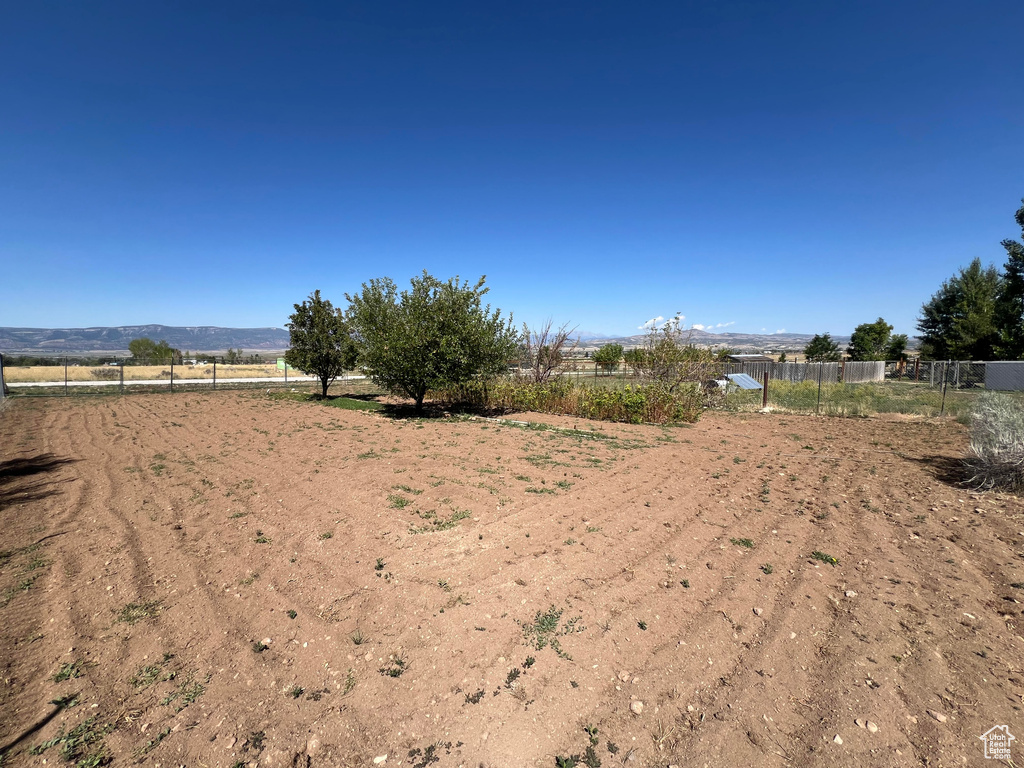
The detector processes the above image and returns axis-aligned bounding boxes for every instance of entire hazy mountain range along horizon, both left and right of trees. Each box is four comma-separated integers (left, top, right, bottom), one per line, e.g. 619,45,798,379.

0,326,919,354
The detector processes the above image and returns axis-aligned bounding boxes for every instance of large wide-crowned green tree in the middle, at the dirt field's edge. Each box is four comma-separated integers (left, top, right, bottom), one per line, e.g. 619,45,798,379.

346,270,521,414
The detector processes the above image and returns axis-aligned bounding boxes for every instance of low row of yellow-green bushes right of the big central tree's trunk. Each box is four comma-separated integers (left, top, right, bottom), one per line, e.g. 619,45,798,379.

429,378,703,424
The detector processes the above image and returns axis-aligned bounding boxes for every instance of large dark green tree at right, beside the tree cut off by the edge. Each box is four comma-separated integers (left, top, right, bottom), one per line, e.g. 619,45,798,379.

918,259,1002,360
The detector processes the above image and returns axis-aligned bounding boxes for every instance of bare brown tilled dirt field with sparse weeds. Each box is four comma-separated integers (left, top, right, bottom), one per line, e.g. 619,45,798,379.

0,392,1024,768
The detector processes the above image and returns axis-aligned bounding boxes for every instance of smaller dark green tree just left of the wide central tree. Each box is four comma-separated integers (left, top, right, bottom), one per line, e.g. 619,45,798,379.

285,291,356,397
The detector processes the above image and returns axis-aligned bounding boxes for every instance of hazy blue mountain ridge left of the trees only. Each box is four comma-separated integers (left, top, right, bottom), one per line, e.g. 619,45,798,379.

0,326,289,353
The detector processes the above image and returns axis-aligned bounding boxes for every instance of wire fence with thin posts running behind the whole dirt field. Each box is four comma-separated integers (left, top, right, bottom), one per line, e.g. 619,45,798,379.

6,354,1024,417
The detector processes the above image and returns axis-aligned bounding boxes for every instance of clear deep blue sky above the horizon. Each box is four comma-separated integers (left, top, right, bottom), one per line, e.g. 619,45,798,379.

0,0,1024,334
